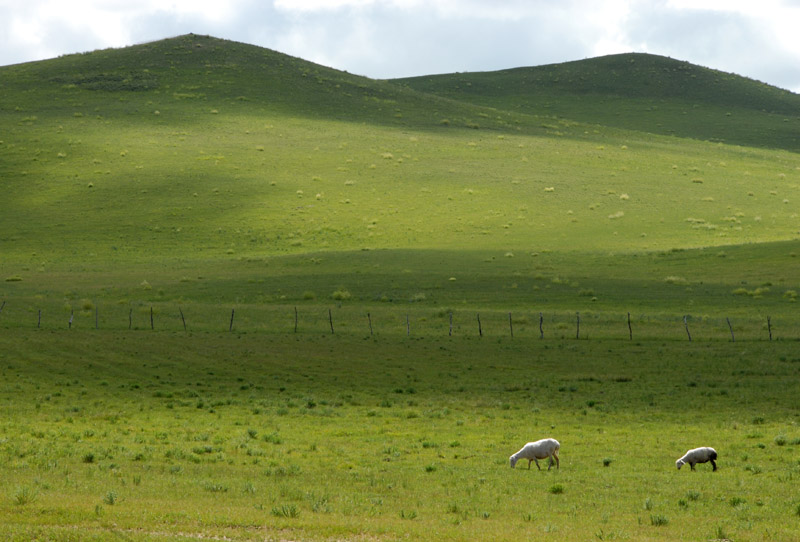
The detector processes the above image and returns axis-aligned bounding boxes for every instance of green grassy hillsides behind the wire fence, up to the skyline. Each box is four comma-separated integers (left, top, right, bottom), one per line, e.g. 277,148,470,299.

0,35,800,326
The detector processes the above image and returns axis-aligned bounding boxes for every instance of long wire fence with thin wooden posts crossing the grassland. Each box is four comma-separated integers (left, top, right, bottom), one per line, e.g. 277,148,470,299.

0,299,800,342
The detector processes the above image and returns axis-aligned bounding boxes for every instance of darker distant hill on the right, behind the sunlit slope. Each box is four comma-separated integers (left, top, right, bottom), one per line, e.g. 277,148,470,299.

396,54,800,151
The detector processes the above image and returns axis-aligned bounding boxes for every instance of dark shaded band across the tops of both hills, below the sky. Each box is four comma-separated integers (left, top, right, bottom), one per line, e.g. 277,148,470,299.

0,34,800,151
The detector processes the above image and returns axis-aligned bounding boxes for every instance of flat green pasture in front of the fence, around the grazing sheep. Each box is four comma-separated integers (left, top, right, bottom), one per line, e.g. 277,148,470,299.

0,329,800,541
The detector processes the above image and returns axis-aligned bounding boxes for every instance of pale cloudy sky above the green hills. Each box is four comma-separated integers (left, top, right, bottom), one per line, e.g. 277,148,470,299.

0,0,800,93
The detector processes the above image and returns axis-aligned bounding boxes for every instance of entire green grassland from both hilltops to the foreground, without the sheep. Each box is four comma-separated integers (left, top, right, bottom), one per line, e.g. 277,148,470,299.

0,35,800,541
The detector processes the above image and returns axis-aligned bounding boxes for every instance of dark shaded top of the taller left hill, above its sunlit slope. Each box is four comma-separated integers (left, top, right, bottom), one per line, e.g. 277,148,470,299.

0,35,532,133
